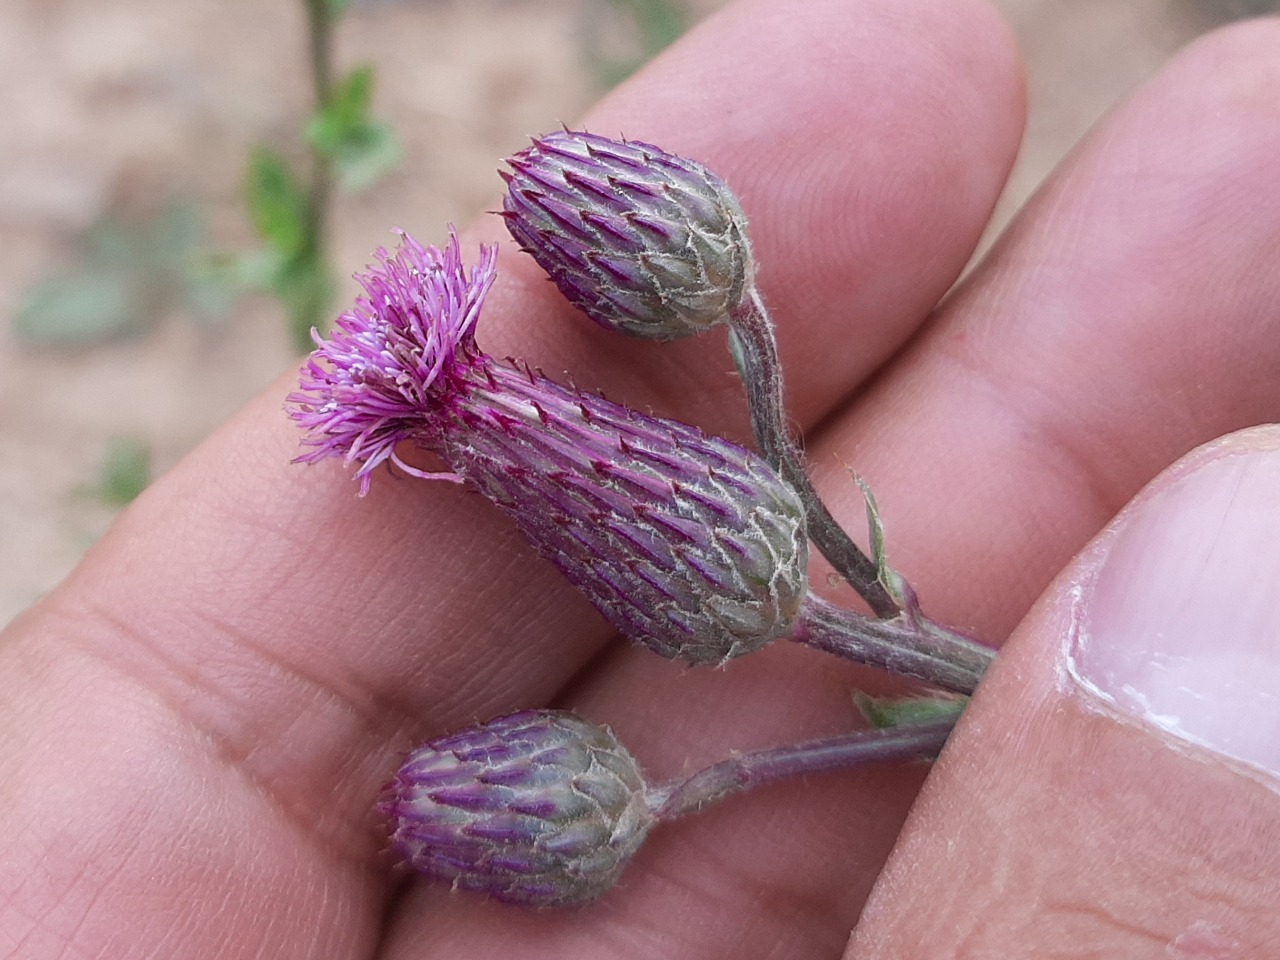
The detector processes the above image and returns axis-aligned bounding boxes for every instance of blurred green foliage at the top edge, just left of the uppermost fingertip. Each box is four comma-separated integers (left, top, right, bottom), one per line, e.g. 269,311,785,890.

582,0,692,88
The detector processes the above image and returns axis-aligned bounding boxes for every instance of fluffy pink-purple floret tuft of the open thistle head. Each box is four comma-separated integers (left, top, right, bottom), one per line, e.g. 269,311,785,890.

288,229,497,494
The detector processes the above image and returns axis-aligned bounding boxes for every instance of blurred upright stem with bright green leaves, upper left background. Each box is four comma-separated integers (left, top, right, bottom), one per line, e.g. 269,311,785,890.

238,0,401,353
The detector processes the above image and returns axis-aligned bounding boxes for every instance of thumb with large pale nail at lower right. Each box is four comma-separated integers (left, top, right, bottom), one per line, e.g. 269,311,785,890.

846,428,1280,960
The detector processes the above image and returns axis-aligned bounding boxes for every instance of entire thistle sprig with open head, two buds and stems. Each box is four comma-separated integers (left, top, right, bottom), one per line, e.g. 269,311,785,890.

288,131,991,906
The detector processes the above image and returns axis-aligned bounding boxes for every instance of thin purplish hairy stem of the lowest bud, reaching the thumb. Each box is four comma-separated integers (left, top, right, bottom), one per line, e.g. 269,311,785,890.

649,717,956,820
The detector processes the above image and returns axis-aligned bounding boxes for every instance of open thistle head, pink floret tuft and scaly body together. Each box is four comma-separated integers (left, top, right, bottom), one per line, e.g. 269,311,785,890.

289,230,808,663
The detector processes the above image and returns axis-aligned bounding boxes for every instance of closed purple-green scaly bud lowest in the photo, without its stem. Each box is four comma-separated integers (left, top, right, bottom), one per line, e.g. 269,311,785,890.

379,710,654,906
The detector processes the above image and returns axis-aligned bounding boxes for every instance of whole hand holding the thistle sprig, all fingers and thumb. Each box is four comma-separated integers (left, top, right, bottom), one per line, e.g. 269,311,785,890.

0,0,1280,960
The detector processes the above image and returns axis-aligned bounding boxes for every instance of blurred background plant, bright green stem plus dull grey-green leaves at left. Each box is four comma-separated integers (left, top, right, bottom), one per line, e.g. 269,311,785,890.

13,0,401,353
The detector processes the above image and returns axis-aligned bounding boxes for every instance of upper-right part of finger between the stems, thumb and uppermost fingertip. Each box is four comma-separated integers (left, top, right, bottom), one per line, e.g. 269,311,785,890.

810,13,1280,640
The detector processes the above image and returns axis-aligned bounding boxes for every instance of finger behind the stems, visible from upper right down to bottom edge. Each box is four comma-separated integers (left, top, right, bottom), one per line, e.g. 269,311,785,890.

384,16,1280,957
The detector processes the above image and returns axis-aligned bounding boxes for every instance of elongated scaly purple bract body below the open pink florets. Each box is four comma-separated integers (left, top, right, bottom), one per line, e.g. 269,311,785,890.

448,364,809,664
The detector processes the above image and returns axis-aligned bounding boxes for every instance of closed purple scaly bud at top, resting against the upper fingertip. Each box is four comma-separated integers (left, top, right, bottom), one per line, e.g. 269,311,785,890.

502,131,753,340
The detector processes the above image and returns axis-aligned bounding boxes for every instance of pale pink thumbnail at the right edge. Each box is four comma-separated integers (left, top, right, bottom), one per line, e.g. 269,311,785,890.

1069,440,1280,777
